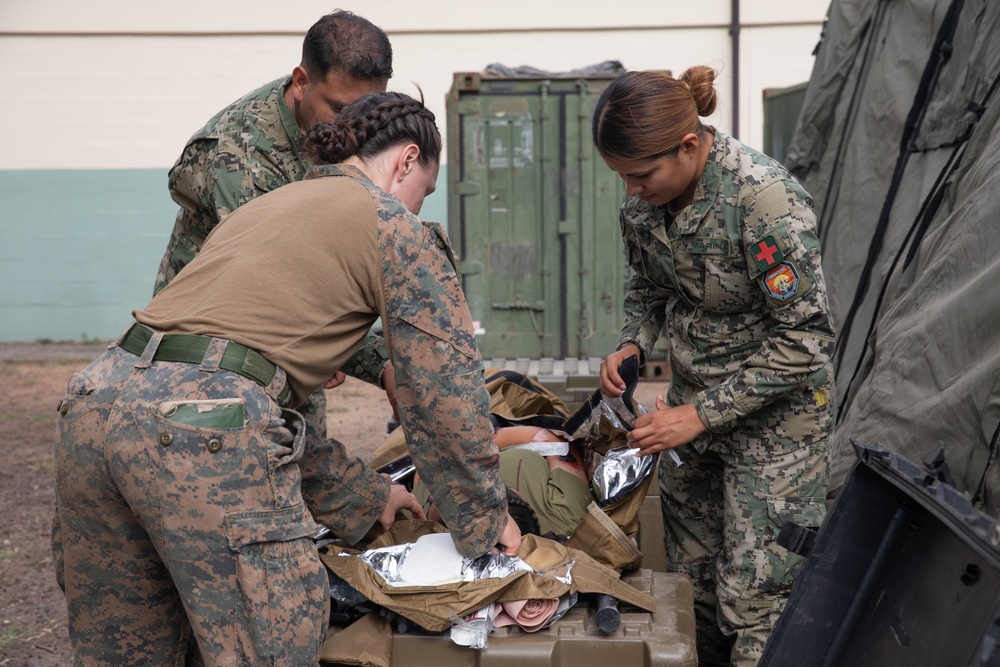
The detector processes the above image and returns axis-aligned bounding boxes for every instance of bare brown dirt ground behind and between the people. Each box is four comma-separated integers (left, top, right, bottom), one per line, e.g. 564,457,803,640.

0,343,666,667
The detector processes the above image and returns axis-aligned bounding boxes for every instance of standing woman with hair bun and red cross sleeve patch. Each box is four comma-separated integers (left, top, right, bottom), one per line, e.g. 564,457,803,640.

593,66,835,666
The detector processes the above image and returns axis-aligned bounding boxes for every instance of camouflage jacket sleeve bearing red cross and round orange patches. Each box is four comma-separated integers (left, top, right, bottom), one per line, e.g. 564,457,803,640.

695,181,835,433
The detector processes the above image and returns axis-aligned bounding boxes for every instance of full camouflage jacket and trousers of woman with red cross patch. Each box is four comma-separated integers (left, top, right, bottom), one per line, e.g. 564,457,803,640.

619,128,835,665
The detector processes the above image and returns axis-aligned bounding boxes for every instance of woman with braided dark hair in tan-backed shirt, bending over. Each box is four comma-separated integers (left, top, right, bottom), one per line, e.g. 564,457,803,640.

53,93,520,667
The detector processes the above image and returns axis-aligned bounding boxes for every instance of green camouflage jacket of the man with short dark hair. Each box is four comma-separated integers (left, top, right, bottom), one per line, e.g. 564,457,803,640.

153,76,388,385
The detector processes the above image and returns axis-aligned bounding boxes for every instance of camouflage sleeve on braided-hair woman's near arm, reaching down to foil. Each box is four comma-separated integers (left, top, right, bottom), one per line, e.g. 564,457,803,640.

379,213,507,557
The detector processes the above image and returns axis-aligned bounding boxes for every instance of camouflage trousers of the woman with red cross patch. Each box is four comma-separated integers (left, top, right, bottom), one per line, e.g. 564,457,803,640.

659,402,830,667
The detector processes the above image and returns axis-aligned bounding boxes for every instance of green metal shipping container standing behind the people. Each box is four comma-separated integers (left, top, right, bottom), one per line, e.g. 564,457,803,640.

447,73,631,366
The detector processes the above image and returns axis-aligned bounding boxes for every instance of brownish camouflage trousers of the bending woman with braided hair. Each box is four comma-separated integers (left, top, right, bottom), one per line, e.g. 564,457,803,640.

52,347,329,667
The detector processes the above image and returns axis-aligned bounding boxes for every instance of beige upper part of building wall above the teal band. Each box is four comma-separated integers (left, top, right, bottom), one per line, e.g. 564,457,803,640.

0,0,829,170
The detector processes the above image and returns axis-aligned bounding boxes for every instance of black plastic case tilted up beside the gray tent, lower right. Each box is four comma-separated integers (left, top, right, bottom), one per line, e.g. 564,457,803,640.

760,442,1000,667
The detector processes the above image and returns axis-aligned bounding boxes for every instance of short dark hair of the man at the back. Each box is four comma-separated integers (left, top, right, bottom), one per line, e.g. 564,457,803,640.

302,9,392,83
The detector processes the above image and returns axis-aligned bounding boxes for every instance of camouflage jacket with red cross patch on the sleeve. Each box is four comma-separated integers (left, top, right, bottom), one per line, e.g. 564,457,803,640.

619,128,834,440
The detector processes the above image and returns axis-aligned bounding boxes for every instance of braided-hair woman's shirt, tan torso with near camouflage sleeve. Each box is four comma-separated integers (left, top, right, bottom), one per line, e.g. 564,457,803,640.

134,165,507,557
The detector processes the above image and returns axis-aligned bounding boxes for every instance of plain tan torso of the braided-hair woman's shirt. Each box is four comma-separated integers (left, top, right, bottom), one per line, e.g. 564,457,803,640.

141,172,384,404
